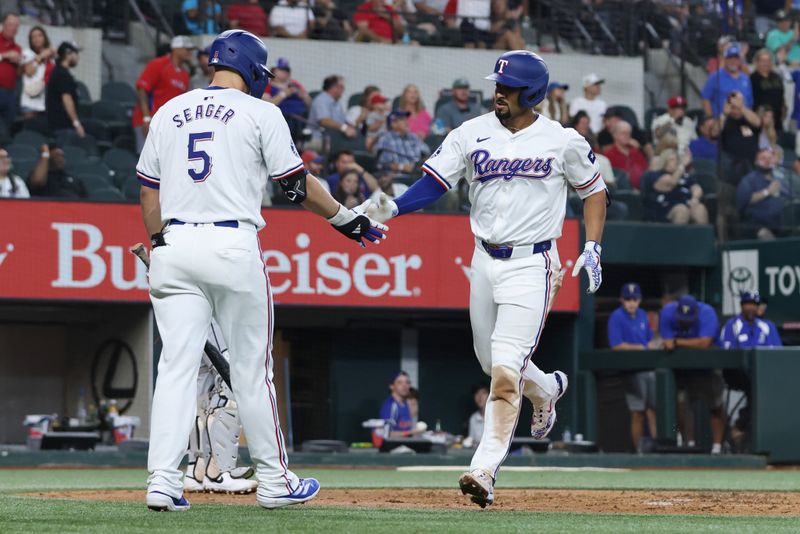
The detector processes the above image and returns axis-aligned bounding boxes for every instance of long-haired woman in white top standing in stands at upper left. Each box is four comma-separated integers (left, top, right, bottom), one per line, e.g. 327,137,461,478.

20,26,56,119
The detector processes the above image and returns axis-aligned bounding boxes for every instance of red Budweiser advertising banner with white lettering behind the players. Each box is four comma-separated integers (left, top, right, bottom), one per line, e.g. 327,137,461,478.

0,200,579,312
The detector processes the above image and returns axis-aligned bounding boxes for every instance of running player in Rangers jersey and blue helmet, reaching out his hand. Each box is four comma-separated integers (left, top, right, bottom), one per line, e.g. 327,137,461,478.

367,50,608,507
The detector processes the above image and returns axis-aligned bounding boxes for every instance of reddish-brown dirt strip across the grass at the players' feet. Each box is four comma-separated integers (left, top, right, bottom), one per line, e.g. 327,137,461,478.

27,488,800,516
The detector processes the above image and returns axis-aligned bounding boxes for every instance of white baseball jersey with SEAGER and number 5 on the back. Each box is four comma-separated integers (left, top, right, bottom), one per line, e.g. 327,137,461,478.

136,87,303,229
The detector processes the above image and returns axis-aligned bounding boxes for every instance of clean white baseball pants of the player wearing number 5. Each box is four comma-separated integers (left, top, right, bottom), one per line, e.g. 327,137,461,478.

147,224,298,498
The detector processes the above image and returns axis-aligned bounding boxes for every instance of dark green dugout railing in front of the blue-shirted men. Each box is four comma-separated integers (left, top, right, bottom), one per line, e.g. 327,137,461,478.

578,347,800,463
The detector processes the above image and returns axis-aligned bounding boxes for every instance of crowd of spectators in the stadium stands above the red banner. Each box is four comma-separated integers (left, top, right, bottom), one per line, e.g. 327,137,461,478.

0,0,800,243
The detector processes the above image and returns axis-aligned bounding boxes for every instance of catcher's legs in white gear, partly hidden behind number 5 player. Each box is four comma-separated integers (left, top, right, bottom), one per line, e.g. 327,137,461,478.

183,319,258,493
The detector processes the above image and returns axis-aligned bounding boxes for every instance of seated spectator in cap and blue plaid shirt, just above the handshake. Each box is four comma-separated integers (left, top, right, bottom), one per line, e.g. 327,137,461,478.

374,111,431,176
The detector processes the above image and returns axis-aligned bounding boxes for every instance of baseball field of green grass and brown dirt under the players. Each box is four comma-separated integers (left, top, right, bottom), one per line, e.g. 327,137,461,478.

0,467,800,534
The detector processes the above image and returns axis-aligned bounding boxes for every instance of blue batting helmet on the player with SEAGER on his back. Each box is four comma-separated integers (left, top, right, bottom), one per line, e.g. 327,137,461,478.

208,30,273,98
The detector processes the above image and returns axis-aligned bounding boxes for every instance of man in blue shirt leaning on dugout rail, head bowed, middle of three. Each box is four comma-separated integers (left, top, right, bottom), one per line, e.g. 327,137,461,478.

659,295,725,454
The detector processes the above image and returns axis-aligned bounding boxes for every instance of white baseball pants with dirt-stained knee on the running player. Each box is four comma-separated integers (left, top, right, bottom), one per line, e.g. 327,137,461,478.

469,241,561,477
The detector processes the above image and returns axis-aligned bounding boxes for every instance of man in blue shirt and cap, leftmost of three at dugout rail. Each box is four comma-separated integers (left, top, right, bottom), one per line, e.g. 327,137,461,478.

608,283,656,450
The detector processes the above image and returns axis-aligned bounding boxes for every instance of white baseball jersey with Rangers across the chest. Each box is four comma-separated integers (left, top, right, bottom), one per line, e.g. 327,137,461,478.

422,112,606,245
